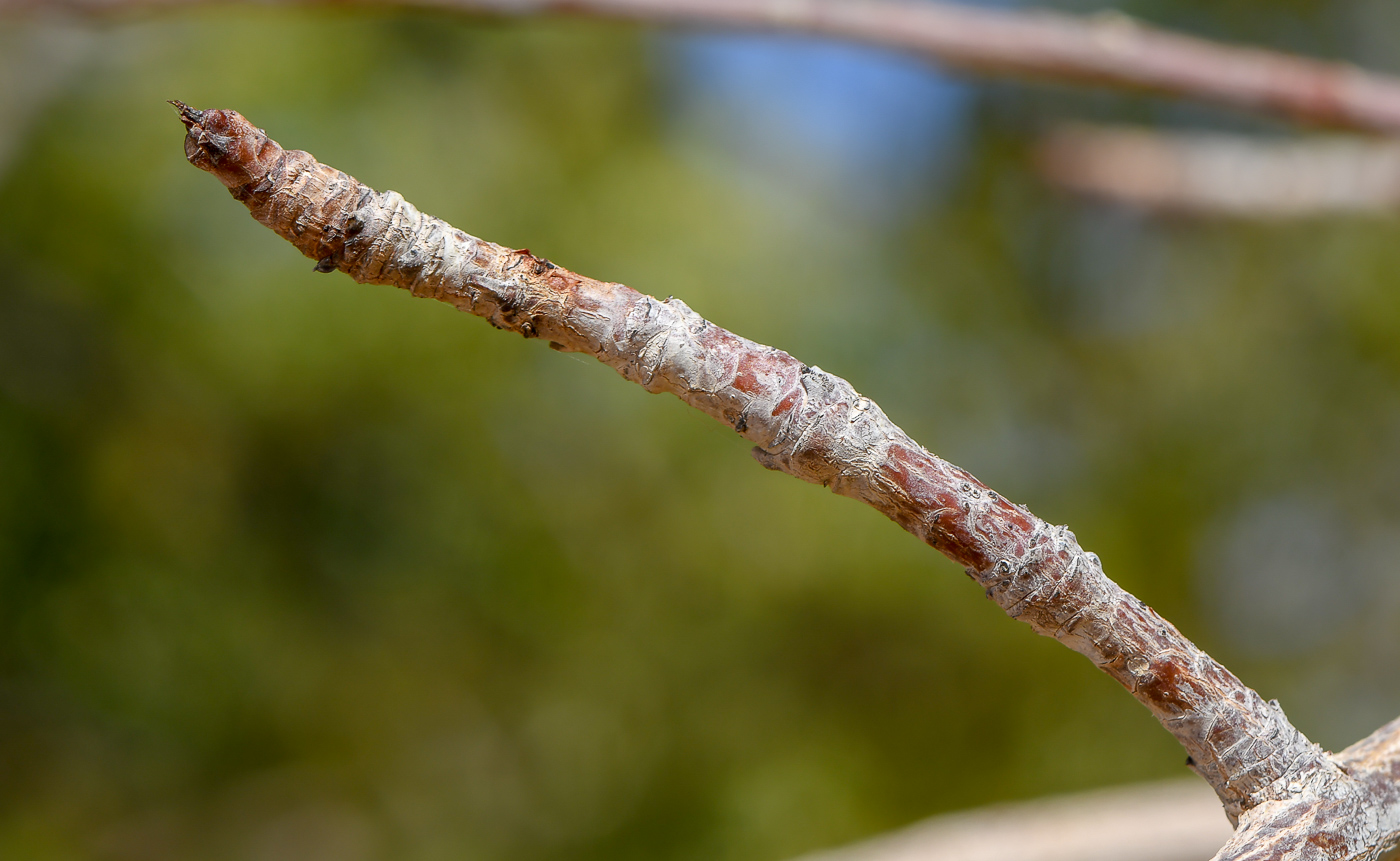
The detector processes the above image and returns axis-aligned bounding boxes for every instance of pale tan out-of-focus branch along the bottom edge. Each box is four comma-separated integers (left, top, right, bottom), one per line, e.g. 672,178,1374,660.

798,781,1231,861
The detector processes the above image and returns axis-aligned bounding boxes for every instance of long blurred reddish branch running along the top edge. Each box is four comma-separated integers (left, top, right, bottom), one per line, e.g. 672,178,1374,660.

13,0,1400,133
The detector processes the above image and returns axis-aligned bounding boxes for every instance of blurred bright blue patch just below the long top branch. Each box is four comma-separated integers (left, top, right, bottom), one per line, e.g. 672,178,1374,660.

658,34,972,221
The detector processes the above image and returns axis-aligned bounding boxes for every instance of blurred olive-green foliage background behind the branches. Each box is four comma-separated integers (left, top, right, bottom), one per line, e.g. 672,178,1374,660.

0,0,1400,861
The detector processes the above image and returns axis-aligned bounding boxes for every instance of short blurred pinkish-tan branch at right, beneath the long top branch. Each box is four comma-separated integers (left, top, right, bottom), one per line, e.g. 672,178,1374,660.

1037,125,1400,218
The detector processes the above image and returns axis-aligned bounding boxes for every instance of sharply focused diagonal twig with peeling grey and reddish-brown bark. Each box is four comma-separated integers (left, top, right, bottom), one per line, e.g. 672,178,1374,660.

172,102,1400,858
